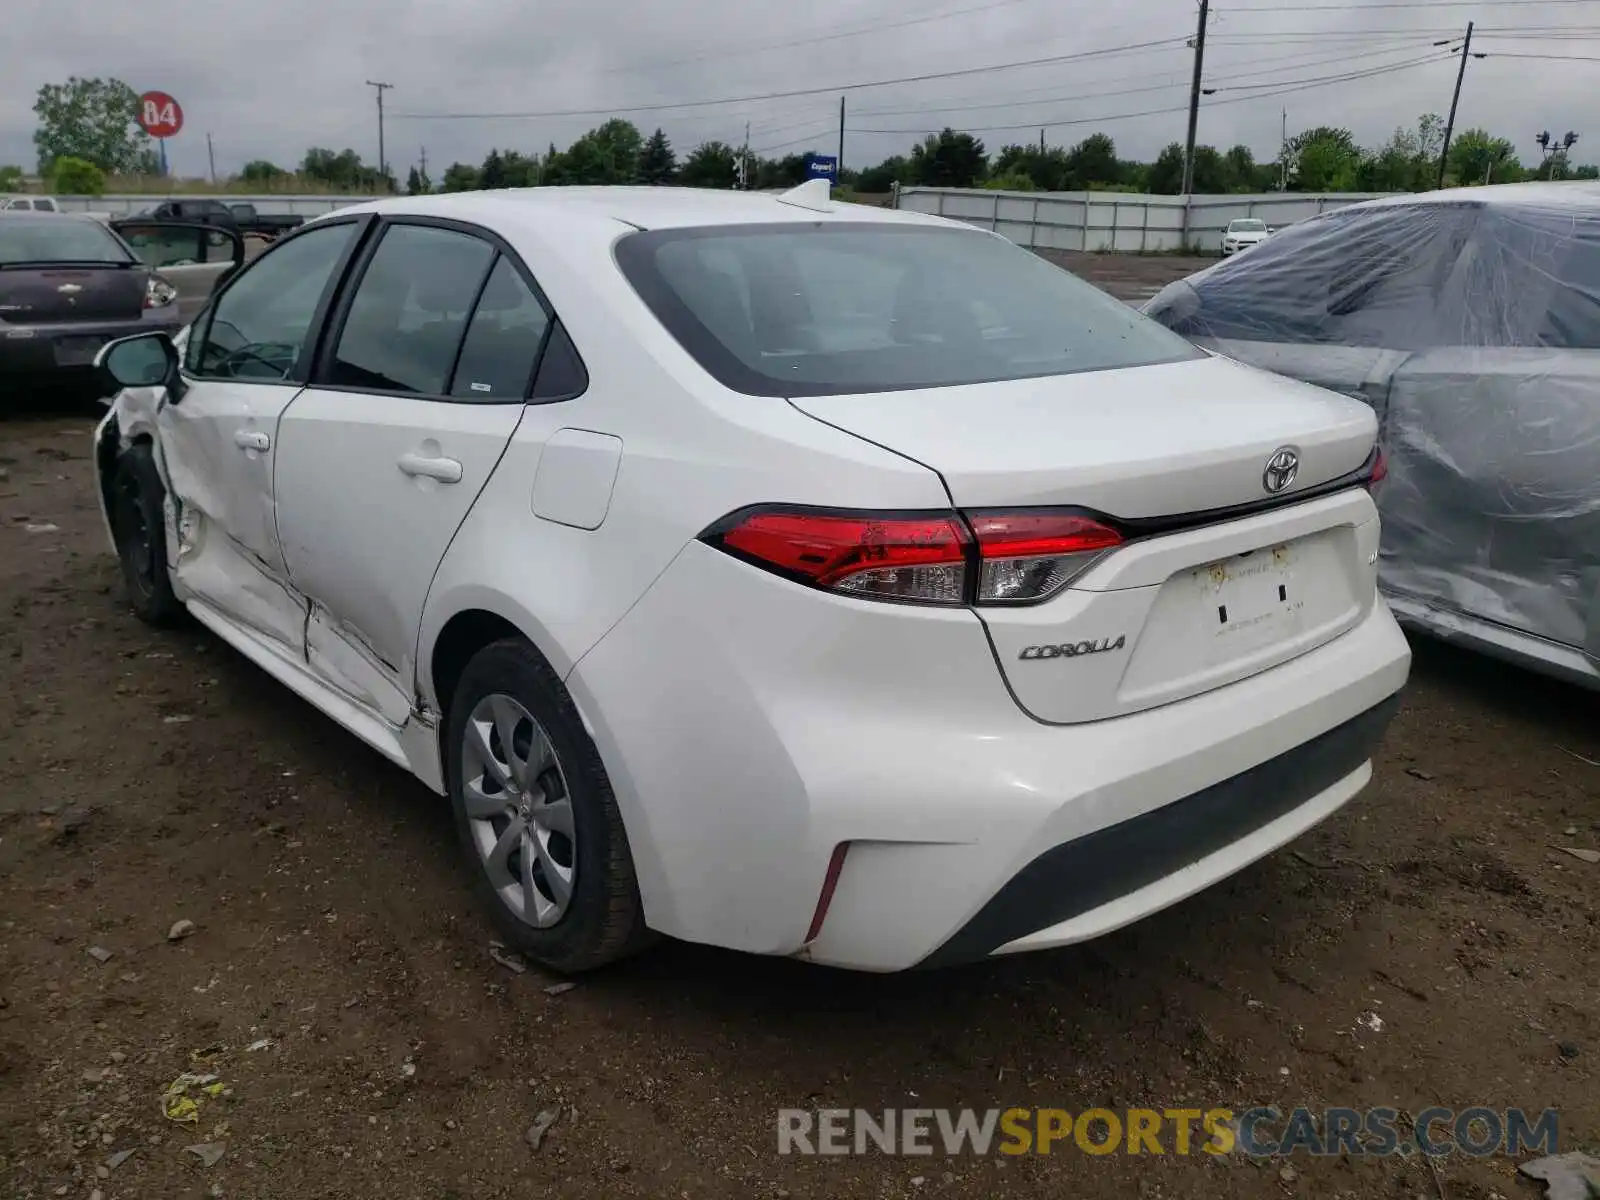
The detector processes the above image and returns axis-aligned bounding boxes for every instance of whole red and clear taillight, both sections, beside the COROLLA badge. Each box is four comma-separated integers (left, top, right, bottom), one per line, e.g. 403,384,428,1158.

702,509,1123,605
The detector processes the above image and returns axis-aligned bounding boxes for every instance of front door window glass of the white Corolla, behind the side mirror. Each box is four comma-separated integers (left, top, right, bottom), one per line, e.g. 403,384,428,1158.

186,222,357,381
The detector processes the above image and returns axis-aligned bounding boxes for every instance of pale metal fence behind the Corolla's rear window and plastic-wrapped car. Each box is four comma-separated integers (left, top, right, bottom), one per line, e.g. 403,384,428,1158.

896,187,1382,253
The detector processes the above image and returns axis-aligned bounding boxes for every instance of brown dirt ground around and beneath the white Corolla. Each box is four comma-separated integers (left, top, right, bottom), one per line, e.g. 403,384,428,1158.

0,256,1600,1200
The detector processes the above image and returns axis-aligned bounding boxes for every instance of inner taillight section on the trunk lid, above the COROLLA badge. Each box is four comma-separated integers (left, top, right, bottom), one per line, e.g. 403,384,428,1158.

968,512,1122,605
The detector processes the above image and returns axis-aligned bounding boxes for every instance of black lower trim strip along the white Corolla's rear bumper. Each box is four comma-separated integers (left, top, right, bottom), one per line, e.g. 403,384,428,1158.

918,693,1400,968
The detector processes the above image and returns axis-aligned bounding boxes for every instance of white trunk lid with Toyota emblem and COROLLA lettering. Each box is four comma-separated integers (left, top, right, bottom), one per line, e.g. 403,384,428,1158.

792,358,1378,723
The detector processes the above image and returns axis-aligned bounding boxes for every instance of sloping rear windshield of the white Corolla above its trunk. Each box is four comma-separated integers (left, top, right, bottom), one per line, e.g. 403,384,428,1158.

616,222,1200,395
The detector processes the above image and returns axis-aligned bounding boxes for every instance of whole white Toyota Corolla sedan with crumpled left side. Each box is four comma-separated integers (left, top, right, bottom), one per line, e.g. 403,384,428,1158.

96,184,1410,971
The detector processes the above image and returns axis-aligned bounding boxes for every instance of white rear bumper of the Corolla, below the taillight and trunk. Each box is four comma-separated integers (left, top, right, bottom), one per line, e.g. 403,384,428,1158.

568,544,1411,971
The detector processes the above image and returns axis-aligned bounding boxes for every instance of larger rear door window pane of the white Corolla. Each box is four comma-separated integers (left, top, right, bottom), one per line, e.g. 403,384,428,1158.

326,226,489,395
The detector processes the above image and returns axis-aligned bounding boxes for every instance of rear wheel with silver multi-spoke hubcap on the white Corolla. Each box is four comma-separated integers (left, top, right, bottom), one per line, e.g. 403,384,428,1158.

445,638,648,973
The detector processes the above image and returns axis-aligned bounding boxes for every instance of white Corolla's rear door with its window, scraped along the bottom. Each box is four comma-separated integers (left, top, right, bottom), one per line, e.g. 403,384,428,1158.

275,218,550,725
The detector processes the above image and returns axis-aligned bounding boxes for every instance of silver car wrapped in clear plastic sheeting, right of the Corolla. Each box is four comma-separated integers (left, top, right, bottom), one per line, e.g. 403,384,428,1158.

1144,175,1600,690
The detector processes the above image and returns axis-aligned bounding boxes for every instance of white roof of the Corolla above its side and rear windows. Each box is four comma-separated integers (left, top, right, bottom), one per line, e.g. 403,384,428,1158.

318,187,957,229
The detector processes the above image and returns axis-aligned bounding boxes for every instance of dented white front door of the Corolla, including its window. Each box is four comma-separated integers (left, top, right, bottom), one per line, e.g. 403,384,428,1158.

157,222,357,658
